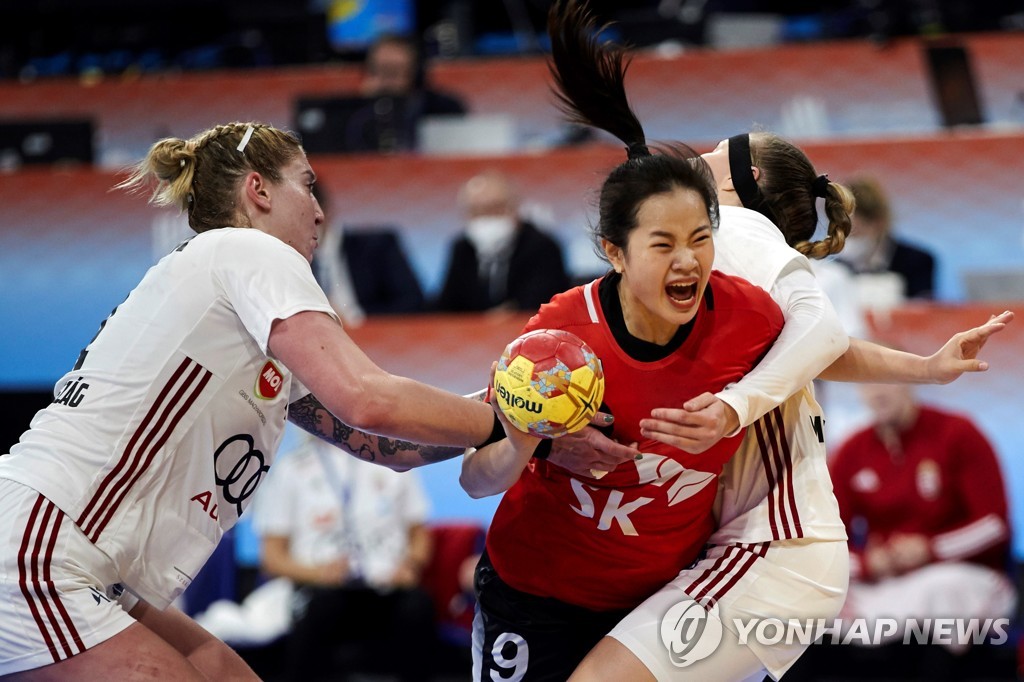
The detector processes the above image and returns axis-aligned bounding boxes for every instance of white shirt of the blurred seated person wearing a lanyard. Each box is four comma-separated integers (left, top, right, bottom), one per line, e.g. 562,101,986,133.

253,436,430,586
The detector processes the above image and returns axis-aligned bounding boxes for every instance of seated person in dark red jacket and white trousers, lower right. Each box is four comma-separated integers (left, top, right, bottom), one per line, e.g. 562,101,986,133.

828,384,1016,655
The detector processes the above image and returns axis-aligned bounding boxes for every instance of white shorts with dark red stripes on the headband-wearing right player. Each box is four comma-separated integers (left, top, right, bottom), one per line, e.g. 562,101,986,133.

609,540,850,681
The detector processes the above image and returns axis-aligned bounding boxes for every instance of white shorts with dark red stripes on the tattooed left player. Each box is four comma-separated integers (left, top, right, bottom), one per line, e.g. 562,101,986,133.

0,479,138,677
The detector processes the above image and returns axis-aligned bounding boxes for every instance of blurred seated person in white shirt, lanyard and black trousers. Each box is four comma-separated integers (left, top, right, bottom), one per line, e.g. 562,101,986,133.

255,434,436,682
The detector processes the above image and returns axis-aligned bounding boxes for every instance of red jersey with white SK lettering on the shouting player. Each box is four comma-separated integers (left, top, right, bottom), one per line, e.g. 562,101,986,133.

487,271,782,610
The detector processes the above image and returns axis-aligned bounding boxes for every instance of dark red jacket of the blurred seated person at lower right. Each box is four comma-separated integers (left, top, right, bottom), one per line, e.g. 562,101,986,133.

828,407,1010,576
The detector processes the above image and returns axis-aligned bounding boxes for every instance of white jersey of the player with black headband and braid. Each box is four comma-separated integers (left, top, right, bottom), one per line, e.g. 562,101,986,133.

710,206,848,545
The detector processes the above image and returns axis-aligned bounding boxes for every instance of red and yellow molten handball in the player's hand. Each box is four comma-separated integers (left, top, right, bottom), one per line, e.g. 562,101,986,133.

495,329,604,438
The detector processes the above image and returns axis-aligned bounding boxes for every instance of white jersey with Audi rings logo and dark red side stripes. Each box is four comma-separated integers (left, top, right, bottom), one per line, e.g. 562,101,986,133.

0,227,335,608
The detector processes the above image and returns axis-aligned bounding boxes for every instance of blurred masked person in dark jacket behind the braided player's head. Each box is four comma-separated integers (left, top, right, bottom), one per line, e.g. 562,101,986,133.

839,176,935,298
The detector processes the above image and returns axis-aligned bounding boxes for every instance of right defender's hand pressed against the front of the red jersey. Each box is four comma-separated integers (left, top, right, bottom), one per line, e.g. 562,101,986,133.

640,393,739,455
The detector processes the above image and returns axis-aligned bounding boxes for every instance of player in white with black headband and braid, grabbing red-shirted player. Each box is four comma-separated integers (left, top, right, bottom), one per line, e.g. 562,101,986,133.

536,2,1010,680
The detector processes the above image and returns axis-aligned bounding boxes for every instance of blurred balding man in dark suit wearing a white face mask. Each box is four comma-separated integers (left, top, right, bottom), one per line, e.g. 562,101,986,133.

435,171,569,312
